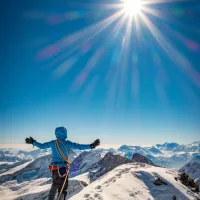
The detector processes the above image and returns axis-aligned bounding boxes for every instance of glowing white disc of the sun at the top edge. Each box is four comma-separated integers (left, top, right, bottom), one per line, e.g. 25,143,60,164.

123,0,142,16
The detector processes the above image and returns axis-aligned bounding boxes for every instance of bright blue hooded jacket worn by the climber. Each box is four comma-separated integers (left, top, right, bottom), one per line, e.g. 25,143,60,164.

33,127,91,167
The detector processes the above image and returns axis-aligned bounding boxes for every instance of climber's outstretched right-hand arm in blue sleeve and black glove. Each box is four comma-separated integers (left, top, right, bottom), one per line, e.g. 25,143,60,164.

65,139,100,150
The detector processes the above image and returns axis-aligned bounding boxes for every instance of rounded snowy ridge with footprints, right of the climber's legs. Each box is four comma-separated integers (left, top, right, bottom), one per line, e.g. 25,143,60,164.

69,163,200,200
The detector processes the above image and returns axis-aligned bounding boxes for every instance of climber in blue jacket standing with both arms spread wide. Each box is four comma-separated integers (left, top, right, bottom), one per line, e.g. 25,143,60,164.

25,127,100,200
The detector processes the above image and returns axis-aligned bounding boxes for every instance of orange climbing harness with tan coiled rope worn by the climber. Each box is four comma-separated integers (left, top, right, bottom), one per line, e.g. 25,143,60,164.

49,140,71,200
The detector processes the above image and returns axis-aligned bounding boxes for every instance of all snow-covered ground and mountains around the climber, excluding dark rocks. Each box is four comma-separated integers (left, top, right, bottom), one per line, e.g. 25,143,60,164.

0,142,200,200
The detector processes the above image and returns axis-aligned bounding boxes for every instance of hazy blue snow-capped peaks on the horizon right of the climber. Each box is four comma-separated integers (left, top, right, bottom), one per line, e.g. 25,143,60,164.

118,142,200,168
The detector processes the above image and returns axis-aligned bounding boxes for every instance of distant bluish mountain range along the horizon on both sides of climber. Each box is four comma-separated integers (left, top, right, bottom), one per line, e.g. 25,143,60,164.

0,141,200,173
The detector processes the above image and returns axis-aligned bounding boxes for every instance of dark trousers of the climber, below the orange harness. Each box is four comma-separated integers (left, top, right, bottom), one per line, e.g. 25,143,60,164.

49,167,68,200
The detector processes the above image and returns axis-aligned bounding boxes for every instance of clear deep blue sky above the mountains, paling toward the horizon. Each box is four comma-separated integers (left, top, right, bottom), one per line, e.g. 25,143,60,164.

0,0,200,145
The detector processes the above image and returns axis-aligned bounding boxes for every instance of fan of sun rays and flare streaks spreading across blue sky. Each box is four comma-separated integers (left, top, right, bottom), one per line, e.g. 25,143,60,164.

32,0,200,106
